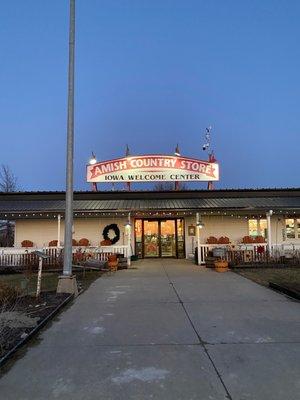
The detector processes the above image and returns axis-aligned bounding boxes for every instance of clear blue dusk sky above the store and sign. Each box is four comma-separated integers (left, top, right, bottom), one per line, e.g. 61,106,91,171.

0,0,300,190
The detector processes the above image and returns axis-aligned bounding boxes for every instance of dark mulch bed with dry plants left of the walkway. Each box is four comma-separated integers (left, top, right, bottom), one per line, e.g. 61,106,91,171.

0,292,70,364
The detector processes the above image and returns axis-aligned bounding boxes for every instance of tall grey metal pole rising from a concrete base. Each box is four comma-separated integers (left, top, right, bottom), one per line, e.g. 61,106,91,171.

63,0,75,276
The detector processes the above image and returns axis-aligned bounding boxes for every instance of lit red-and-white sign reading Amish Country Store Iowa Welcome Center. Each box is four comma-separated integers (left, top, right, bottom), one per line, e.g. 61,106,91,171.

87,155,219,182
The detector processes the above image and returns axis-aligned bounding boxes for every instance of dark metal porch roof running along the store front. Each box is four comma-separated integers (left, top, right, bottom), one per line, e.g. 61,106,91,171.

0,189,300,219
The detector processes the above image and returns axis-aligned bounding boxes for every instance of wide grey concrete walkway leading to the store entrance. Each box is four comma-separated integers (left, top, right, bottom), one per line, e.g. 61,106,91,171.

0,260,300,400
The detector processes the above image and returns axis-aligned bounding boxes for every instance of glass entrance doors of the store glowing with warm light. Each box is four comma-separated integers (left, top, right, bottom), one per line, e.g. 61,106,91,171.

135,218,185,258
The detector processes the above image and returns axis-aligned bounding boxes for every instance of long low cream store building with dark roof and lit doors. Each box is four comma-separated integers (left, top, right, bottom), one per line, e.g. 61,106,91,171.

0,189,300,264
